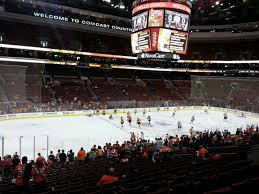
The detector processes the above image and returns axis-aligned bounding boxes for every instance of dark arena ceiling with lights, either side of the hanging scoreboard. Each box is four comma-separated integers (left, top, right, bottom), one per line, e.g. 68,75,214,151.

34,0,259,25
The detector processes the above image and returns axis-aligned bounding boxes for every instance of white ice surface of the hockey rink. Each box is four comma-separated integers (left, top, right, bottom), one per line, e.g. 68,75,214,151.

0,109,259,159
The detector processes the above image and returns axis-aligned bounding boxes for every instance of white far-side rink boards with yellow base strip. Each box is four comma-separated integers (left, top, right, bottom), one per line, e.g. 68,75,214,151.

0,106,259,121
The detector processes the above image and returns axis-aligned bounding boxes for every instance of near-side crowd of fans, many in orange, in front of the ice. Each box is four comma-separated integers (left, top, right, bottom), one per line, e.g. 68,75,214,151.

0,123,259,191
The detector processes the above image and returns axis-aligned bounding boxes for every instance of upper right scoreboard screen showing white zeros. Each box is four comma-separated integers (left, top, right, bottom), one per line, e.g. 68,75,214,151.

165,10,190,32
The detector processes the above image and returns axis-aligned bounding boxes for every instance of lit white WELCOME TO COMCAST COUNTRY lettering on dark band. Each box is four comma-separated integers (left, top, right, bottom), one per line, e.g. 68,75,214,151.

33,12,132,32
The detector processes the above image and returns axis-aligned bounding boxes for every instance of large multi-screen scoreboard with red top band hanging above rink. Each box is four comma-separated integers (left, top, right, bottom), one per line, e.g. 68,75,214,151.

131,0,191,59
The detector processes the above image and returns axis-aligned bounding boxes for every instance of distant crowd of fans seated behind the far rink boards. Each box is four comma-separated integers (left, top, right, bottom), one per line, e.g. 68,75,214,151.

0,97,257,115
